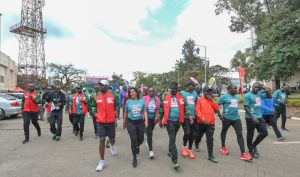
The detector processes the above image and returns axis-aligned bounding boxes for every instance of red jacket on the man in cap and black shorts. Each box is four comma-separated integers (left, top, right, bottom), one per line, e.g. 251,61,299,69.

95,91,116,124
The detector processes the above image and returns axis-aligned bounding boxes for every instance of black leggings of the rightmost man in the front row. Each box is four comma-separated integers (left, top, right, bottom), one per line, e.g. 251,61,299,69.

246,118,268,151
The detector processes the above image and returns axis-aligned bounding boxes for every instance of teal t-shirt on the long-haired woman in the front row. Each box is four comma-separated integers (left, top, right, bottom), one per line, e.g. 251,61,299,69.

125,99,146,120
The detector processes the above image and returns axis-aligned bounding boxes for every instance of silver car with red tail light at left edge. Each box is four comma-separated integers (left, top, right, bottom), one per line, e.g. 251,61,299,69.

0,94,22,120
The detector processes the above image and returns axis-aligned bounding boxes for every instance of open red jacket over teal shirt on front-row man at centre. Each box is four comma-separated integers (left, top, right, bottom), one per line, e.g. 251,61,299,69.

162,93,184,125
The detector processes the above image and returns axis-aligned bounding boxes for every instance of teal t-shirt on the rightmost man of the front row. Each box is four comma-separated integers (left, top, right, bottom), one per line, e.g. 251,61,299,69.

244,92,262,119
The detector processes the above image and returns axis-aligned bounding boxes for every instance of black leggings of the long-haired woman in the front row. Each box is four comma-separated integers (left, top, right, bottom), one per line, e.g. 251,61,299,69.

126,118,145,159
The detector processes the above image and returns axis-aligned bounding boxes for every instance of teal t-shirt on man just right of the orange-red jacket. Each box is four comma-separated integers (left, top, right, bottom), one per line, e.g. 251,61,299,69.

217,93,240,120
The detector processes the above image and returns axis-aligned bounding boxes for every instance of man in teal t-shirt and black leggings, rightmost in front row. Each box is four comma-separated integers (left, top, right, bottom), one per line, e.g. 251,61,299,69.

244,83,268,158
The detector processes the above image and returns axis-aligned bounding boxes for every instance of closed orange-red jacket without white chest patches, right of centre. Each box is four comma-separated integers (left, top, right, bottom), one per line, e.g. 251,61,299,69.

196,96,220,125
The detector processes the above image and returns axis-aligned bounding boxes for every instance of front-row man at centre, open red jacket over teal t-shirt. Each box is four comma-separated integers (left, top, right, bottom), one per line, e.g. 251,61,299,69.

160,82,191,170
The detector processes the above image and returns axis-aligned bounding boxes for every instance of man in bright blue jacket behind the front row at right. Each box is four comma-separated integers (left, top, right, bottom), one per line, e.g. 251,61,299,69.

261,87,285,141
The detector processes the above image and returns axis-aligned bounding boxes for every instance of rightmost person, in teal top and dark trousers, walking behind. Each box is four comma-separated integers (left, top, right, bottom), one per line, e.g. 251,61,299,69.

272,86,289,131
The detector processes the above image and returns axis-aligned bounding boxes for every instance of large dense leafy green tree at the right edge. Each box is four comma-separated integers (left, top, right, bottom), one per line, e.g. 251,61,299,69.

255,0,300,87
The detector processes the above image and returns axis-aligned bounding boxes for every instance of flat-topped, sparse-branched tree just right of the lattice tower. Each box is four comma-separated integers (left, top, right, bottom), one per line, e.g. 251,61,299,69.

47,63,86,89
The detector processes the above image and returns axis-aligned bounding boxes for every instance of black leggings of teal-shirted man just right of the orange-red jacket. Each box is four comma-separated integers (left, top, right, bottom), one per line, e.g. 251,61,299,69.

221,118,245,153
